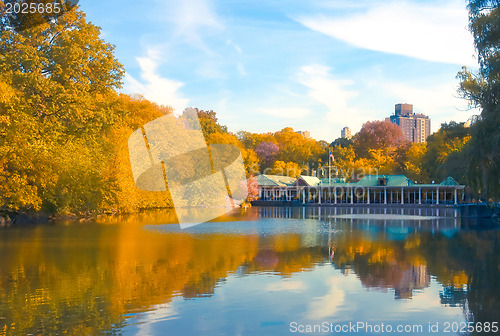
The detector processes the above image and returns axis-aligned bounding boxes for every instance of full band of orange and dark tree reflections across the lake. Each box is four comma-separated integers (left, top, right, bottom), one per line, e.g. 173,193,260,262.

0,210,500,335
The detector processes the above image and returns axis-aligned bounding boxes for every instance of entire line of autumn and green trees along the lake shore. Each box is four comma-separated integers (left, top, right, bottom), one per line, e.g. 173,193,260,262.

0,1,500,217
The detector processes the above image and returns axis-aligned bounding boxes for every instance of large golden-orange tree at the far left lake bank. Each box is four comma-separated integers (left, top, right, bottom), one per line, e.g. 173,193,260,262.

0,10,123,212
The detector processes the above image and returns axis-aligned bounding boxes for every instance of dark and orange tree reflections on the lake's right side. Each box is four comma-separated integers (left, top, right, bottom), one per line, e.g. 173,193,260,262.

332,223,500,334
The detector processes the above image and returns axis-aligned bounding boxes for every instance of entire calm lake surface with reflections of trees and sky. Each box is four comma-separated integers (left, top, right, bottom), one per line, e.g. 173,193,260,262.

0,207,500,335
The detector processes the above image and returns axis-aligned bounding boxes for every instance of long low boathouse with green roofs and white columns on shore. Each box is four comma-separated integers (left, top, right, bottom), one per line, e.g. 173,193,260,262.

257,175,465,206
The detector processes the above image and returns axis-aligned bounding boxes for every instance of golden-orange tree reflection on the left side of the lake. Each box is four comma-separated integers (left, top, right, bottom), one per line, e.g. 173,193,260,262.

0,214,327,335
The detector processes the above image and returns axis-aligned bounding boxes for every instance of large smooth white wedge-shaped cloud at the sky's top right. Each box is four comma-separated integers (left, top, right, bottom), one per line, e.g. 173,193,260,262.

297,1,476,65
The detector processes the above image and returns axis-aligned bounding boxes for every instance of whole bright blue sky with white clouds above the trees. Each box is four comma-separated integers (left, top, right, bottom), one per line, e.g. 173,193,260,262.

80,0,477,142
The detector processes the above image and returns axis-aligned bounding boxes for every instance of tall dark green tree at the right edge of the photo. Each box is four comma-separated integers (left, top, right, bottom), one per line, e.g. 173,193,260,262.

458,0,500,199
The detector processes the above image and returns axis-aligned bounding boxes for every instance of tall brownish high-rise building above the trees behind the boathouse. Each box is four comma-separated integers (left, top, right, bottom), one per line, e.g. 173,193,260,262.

386,104,431,143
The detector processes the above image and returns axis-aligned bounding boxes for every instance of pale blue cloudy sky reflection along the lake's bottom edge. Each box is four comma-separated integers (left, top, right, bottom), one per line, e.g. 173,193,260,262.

123,265,464,335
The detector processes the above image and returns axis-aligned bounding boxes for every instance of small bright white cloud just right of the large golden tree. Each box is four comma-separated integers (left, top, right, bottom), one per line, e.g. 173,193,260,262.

124,49,189,113
